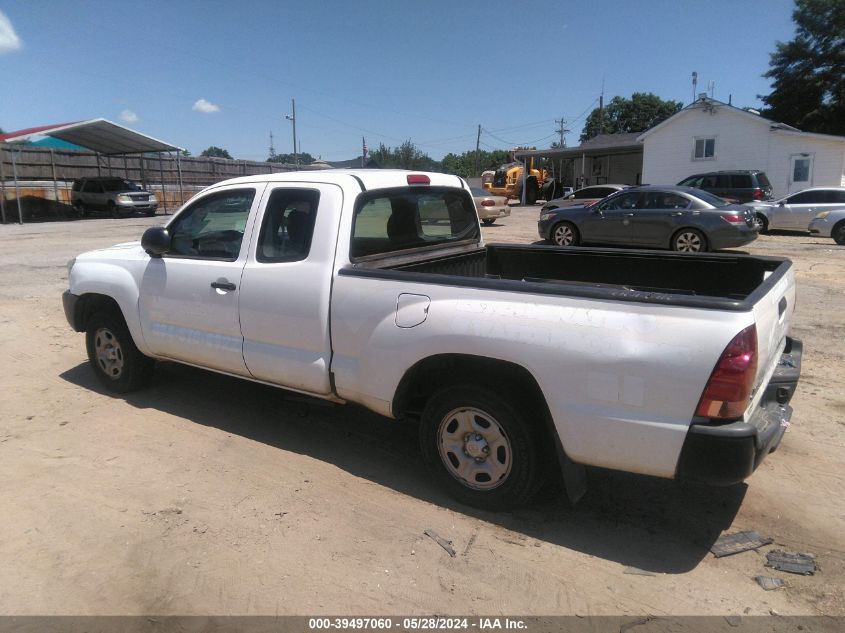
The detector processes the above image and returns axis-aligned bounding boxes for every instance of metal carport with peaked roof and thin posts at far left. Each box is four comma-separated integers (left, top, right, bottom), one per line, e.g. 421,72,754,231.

0,119,184,224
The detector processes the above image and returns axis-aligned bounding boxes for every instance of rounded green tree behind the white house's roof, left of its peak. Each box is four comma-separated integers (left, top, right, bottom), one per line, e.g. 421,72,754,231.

581,92,684,142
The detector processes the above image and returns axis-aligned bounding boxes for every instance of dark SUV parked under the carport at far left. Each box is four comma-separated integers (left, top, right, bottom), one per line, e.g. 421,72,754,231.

71,176,158,218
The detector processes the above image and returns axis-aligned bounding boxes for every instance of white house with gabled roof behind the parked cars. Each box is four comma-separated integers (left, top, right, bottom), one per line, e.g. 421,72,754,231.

638,95,845,198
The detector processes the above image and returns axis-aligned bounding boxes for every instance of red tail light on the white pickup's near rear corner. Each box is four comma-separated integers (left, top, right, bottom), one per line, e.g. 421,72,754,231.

695,325,757,420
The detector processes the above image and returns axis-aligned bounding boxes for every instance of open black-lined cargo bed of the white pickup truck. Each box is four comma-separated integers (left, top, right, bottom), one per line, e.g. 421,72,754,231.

340,244,791,311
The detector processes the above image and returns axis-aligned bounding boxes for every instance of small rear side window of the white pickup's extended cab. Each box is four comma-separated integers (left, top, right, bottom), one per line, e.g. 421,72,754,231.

255,189,320,263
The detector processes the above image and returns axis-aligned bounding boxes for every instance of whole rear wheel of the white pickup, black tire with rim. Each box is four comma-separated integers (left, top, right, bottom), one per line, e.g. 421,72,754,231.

420,384,543,510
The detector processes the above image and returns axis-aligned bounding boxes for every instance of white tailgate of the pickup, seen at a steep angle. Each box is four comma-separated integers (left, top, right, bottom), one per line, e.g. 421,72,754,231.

746,264,795,416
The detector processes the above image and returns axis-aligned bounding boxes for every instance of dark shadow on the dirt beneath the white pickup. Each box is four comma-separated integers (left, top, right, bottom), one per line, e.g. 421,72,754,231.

61,363,746,574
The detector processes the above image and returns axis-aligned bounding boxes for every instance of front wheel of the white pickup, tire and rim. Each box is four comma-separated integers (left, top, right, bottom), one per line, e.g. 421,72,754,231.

85,312,155,393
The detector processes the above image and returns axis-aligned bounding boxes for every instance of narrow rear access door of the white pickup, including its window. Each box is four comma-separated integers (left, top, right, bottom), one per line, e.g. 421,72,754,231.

240,183,343,394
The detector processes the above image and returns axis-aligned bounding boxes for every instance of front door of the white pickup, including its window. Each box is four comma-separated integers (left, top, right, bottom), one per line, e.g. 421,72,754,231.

139,185,264,376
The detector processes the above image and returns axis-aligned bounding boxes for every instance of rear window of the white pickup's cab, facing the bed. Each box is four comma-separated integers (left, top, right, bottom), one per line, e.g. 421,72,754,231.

349,187,479,259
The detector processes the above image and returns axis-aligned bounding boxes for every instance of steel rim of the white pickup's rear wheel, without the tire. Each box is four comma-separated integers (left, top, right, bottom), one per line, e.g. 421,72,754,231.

437,407,512,490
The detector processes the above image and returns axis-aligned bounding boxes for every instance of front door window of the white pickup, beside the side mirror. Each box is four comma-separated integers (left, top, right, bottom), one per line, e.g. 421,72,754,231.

166,189,255,262
